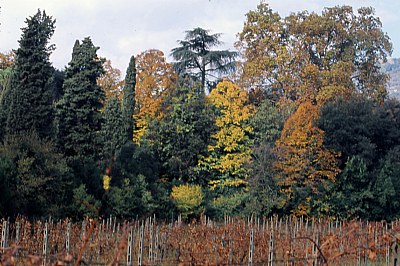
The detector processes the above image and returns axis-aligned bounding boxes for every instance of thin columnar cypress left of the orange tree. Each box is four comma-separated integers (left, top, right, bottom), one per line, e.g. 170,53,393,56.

122,56,136,143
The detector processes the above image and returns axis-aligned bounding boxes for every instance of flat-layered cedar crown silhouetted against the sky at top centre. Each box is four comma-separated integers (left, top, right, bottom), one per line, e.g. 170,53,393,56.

171,28,238,91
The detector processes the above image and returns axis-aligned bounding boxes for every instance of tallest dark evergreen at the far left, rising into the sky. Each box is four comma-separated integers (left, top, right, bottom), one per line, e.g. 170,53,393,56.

5,10,55,137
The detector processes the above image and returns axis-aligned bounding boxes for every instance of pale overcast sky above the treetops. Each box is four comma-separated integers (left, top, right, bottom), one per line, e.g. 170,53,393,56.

0,0,400,73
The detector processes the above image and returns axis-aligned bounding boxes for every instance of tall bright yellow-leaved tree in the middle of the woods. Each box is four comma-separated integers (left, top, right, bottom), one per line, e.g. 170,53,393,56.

199,81,254,187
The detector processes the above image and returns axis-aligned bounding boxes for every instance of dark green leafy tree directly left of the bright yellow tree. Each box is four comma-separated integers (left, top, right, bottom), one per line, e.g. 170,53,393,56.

145,78,213,184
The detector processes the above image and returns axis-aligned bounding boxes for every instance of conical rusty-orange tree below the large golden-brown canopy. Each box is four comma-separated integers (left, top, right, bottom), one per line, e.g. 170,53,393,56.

274,101,339,215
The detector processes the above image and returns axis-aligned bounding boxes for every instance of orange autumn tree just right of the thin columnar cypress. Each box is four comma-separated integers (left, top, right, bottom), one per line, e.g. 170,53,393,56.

134,49,177,143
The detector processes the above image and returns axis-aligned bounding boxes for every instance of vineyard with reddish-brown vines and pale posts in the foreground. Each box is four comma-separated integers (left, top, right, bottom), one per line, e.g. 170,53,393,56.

1,217,400,265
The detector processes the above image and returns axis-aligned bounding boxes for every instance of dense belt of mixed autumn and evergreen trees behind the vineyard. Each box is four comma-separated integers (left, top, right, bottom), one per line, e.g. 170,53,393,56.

0,2,400,220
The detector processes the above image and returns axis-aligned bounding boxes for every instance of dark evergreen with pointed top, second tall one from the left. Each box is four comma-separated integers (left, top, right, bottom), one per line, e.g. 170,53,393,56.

56,37,105,161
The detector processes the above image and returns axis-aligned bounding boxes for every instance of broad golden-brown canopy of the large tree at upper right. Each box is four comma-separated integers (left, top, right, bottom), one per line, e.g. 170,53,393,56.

236,3,392,103
